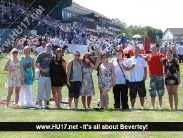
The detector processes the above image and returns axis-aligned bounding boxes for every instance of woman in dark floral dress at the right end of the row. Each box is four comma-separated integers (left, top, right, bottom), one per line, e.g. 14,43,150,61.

164,50,180,110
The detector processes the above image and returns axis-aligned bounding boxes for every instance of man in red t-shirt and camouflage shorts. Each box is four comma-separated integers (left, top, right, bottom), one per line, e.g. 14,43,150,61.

145,44,165,109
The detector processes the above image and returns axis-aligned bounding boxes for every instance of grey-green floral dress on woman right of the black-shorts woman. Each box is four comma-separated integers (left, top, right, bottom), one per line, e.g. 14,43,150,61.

80,67,95,96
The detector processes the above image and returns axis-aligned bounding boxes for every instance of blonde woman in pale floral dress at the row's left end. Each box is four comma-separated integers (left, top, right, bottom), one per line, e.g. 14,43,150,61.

4,48,24,108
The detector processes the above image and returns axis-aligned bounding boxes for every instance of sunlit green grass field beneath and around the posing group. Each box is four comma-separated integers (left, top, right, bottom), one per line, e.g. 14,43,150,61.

0,52,183,138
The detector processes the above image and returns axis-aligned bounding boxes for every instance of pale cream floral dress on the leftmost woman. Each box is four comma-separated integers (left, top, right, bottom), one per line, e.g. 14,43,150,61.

5,59,21,87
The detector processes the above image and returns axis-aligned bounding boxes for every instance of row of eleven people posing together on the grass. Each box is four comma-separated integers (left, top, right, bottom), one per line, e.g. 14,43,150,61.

4,43,180,110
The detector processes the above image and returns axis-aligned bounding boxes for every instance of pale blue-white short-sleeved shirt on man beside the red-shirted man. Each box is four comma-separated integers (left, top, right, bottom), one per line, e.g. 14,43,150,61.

127,56,147,82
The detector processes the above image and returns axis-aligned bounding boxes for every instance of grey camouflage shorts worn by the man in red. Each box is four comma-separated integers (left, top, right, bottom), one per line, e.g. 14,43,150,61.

149,76,164,97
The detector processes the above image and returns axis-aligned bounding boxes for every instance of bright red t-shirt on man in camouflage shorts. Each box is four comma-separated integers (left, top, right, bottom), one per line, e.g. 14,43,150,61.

146,53,165,76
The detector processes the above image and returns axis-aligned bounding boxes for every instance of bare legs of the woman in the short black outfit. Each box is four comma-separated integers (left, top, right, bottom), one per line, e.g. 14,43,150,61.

52,87,62,109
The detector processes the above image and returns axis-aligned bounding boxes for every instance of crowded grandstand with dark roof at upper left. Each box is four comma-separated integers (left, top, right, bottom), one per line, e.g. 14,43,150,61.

0,0,121,46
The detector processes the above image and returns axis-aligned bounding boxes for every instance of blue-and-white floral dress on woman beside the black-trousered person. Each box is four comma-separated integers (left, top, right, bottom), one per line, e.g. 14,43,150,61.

99,64,112,92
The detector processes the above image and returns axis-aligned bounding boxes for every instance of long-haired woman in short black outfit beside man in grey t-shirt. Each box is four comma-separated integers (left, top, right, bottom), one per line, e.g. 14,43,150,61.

50,48,66,109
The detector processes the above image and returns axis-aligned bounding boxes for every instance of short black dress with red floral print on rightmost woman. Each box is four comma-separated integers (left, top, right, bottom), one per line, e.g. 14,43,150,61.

164,59,179,85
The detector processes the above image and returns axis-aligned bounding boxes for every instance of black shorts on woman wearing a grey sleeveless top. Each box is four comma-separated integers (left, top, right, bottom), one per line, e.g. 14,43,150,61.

68,81,82,99
